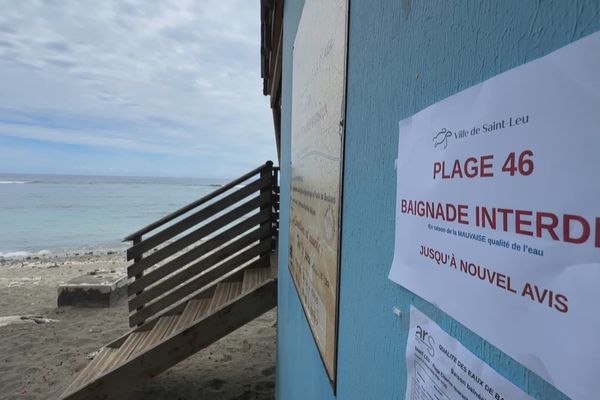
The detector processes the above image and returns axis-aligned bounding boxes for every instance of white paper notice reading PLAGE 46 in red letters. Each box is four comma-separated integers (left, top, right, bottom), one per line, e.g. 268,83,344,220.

389,32,600,400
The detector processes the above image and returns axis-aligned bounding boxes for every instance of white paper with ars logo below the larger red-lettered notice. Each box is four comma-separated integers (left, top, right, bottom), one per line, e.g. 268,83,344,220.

405,306,531,400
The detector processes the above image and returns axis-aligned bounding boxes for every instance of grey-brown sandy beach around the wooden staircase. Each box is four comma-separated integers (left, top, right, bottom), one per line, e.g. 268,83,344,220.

0,251,276,400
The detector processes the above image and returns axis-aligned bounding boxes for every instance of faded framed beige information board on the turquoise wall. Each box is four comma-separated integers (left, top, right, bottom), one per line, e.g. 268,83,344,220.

289,0,348,381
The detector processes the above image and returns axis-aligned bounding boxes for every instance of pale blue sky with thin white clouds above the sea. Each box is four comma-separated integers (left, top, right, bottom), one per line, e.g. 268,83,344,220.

0,0,276,178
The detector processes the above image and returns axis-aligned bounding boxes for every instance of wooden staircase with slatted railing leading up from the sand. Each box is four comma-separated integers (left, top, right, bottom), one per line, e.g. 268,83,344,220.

61,162,279,400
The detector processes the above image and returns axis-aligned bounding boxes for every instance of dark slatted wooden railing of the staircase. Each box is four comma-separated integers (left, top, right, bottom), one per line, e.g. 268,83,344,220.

124,161,279,327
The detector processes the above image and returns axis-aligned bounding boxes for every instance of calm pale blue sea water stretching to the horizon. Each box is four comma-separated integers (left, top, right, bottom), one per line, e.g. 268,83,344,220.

0,174,223,257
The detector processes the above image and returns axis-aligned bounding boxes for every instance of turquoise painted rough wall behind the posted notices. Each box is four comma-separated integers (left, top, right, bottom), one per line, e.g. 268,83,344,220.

277,0,600,400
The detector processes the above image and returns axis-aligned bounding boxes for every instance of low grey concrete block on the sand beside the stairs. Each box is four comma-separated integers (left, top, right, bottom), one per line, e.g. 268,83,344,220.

57,271,127,307
